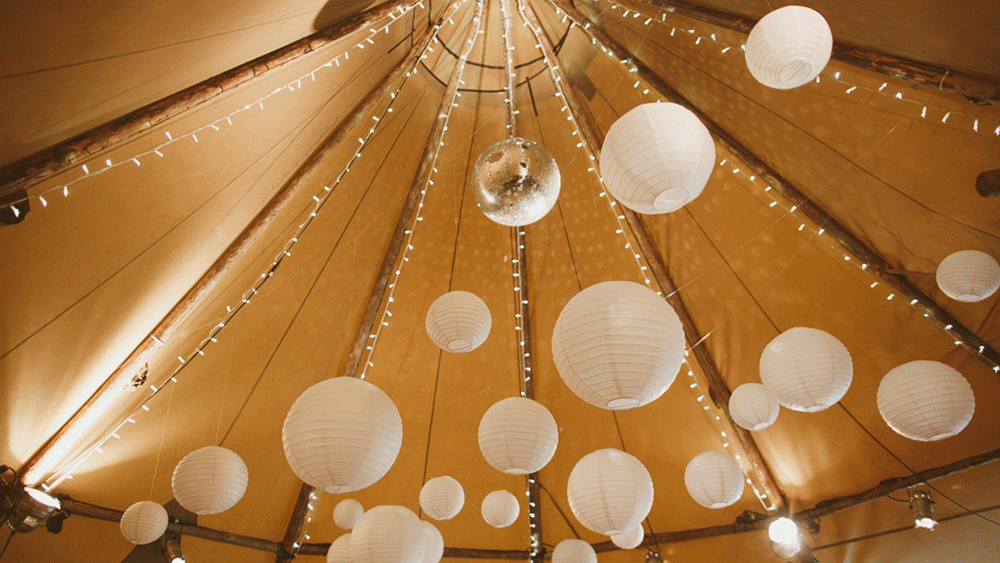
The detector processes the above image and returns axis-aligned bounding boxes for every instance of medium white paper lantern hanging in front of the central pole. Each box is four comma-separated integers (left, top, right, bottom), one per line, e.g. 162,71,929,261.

479,397,559,475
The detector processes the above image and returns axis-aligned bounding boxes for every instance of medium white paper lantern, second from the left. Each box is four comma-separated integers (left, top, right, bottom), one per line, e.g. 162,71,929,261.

170,446,250,515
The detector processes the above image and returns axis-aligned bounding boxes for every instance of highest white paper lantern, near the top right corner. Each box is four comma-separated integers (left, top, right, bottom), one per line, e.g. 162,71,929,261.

746,6,833,90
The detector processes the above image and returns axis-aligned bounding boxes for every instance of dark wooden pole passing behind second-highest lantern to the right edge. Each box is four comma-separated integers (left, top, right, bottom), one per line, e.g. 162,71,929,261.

548,0,1000,372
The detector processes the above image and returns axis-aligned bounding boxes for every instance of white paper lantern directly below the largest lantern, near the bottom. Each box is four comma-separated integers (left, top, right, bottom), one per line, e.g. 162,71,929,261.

566,448,653,536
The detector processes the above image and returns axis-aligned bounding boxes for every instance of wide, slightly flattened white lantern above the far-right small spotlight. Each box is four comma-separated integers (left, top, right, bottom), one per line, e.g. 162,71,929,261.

877,360,976,442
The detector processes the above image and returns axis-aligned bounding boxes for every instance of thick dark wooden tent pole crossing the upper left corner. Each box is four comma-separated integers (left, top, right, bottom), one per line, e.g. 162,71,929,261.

0,0,418,198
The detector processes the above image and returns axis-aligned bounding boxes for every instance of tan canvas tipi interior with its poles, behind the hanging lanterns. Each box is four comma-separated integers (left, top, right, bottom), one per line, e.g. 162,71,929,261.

0,0,1000,563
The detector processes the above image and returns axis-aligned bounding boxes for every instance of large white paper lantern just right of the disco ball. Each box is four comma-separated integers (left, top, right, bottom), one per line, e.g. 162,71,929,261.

600,103,715,213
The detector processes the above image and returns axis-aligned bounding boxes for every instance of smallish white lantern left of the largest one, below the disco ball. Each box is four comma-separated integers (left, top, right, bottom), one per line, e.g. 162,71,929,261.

425,291,493,354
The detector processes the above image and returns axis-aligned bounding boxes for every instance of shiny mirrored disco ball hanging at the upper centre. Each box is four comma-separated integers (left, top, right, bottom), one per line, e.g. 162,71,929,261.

472,137,560,227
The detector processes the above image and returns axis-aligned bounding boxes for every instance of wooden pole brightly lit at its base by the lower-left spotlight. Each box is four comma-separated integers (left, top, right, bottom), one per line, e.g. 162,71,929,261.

21,7,448,485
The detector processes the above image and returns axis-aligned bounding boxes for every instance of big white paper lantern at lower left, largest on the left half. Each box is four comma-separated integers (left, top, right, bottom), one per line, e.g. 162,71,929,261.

281,377,403,493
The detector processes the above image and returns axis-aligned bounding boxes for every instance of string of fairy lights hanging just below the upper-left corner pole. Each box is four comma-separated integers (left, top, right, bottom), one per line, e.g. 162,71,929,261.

10,0,424,217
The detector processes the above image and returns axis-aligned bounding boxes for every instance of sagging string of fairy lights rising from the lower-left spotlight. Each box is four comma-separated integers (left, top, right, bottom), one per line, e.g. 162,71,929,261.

37,0,467,490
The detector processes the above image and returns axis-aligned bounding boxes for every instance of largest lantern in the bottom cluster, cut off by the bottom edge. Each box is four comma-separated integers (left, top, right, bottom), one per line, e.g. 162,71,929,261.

351,506,427,563
